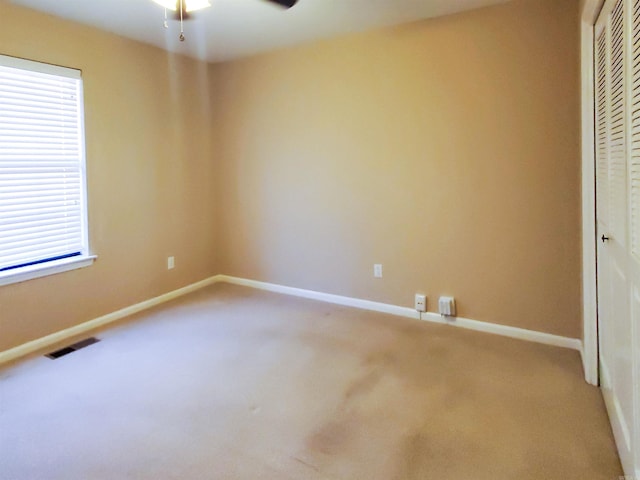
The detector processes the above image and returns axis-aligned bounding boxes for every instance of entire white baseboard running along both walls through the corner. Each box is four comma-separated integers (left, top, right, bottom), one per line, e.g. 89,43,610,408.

0,275,582,365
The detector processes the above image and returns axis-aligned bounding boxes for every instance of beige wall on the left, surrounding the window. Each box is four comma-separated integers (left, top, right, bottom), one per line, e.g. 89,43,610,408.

0,2,218,351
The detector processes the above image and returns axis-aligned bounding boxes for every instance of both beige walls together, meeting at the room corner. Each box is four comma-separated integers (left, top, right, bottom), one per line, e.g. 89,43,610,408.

0,0,581,351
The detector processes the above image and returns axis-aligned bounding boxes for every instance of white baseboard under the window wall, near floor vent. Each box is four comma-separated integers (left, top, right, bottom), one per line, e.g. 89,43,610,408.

0,276,219,365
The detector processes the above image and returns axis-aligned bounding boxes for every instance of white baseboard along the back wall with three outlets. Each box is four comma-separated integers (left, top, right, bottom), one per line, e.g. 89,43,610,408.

218,275,582,352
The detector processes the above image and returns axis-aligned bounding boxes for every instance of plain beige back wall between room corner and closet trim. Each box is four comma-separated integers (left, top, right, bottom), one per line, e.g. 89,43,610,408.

211,0,581,337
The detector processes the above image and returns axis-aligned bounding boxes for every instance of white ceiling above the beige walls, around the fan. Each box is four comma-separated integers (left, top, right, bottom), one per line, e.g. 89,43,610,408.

11,0,508,62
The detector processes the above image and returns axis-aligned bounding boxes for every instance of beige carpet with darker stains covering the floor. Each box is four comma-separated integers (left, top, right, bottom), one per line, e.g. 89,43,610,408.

0,284,622,480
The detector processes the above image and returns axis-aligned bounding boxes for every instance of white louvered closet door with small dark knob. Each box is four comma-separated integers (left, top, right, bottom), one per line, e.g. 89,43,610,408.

595,0,640,478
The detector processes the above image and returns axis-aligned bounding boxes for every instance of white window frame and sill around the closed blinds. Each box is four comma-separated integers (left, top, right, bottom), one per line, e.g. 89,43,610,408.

0,55,97,286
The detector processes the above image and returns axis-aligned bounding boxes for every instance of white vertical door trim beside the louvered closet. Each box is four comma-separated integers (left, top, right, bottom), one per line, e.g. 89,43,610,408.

580,0,604,385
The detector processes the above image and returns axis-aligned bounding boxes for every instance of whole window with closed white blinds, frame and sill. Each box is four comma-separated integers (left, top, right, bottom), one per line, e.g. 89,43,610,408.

0,55,94,285
